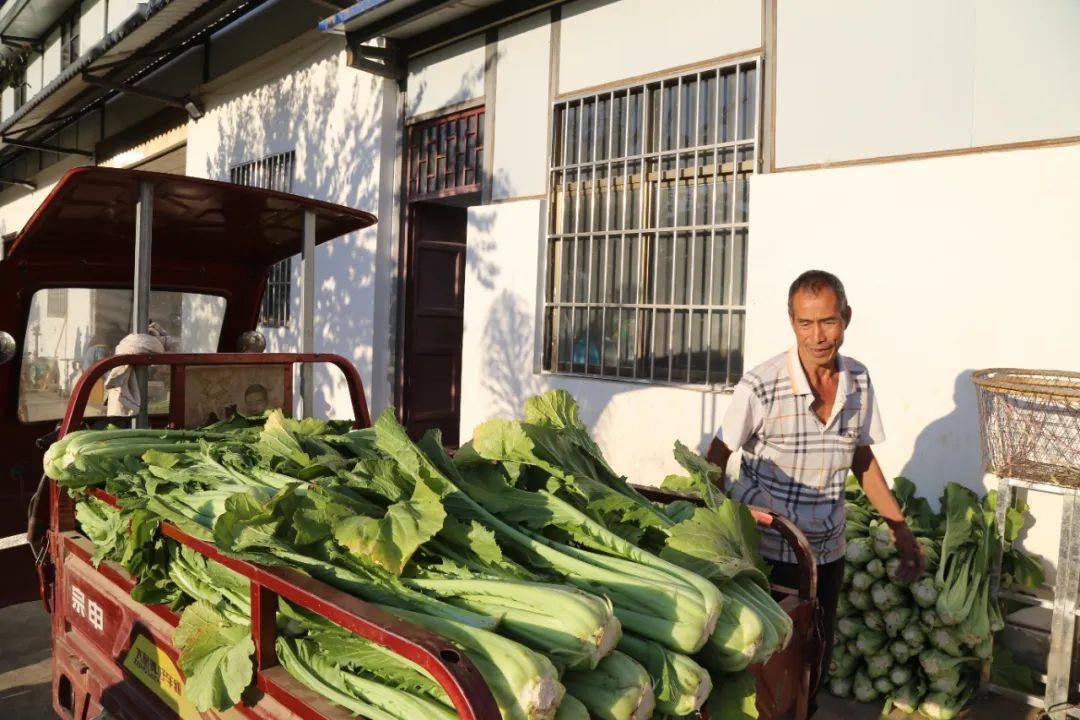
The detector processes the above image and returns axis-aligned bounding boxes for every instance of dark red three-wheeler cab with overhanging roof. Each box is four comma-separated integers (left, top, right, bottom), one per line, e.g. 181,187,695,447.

0,167,375,607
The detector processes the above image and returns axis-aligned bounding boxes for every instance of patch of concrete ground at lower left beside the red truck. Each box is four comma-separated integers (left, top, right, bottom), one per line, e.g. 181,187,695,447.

0,600,56,720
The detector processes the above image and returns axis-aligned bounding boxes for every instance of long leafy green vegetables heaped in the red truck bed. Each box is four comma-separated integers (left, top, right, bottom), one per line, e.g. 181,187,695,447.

45,391,792,720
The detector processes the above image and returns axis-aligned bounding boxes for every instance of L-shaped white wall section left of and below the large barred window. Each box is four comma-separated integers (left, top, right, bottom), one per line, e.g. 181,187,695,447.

461,200,729,484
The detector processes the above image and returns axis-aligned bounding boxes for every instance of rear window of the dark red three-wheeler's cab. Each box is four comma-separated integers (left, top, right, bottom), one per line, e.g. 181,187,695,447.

18,287,225,422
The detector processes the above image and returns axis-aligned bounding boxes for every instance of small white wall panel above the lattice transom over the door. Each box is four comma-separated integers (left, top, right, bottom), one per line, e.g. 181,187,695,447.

406,35,485,118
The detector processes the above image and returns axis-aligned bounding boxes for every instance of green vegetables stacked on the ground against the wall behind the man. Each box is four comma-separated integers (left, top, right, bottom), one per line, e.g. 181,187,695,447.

829,477,1043,720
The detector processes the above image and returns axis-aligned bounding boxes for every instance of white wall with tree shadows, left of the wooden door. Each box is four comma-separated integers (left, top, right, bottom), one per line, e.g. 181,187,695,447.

187,33,396,417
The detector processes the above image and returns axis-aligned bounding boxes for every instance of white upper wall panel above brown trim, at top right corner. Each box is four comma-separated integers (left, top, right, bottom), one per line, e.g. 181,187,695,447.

775,0,1080,167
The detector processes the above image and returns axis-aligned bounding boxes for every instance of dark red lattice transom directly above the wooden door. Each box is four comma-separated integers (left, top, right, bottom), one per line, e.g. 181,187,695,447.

408,106,484,200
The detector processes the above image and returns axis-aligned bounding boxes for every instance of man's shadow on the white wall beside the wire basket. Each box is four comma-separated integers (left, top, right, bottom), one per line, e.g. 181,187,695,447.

898,369,983,504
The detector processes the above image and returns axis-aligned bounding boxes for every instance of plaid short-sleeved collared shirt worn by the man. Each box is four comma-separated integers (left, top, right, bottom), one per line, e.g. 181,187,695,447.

717,348,885,565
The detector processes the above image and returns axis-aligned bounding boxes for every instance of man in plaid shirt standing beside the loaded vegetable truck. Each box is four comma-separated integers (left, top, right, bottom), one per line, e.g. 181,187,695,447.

708,270,924,699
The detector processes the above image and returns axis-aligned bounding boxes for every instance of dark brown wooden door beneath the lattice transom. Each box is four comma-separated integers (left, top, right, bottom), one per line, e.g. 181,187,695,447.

402,202,468,447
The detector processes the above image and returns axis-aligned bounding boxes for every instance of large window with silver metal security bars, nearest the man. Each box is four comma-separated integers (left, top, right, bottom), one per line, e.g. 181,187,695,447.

543,59,760,385
